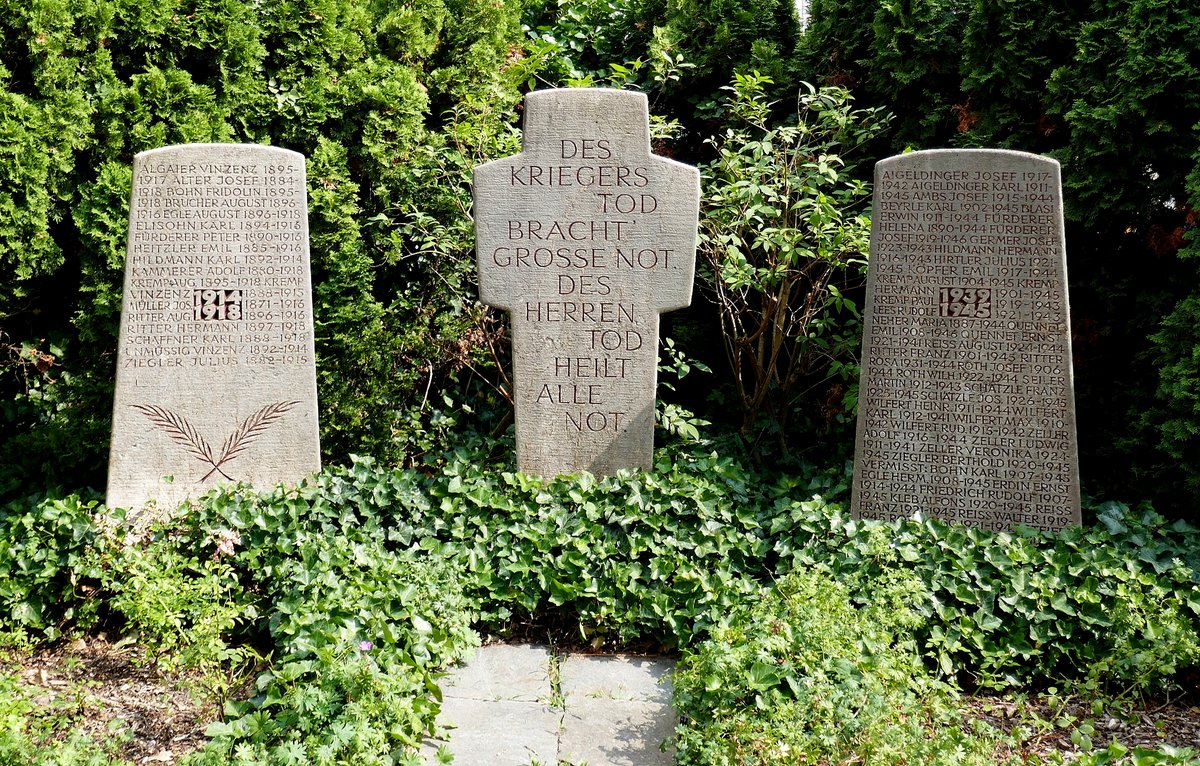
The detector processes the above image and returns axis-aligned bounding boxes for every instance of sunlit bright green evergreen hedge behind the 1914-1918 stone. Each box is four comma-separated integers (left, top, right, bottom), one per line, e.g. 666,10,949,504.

0,0,524,489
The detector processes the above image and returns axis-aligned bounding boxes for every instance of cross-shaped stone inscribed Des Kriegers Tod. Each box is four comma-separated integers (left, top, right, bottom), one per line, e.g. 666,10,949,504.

474,89,700,475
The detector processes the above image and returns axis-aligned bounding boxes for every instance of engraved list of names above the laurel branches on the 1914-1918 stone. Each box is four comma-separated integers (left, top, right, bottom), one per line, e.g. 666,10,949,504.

121,157,312,369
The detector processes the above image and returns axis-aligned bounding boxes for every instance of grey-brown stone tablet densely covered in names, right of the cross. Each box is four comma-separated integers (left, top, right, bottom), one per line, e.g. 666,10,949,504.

852,150,1080,529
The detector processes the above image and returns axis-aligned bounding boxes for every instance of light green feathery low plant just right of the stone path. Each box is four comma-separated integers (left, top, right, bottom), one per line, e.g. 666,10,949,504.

674,573,996,766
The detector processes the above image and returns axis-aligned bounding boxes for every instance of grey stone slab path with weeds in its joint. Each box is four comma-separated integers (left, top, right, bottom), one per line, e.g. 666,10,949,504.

424,645,678,766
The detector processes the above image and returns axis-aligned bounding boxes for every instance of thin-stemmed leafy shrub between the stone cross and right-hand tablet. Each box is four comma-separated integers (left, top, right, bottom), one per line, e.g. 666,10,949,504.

700,73,887,451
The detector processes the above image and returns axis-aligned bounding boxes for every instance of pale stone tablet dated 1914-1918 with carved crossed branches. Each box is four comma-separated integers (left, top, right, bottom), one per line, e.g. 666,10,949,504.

107,144,320,508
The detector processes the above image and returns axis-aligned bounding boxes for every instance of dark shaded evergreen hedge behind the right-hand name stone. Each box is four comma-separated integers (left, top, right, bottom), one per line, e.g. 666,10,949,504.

800,0,1200,523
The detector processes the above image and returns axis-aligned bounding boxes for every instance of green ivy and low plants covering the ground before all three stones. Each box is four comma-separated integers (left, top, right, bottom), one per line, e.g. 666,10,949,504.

0,444,1200,765
